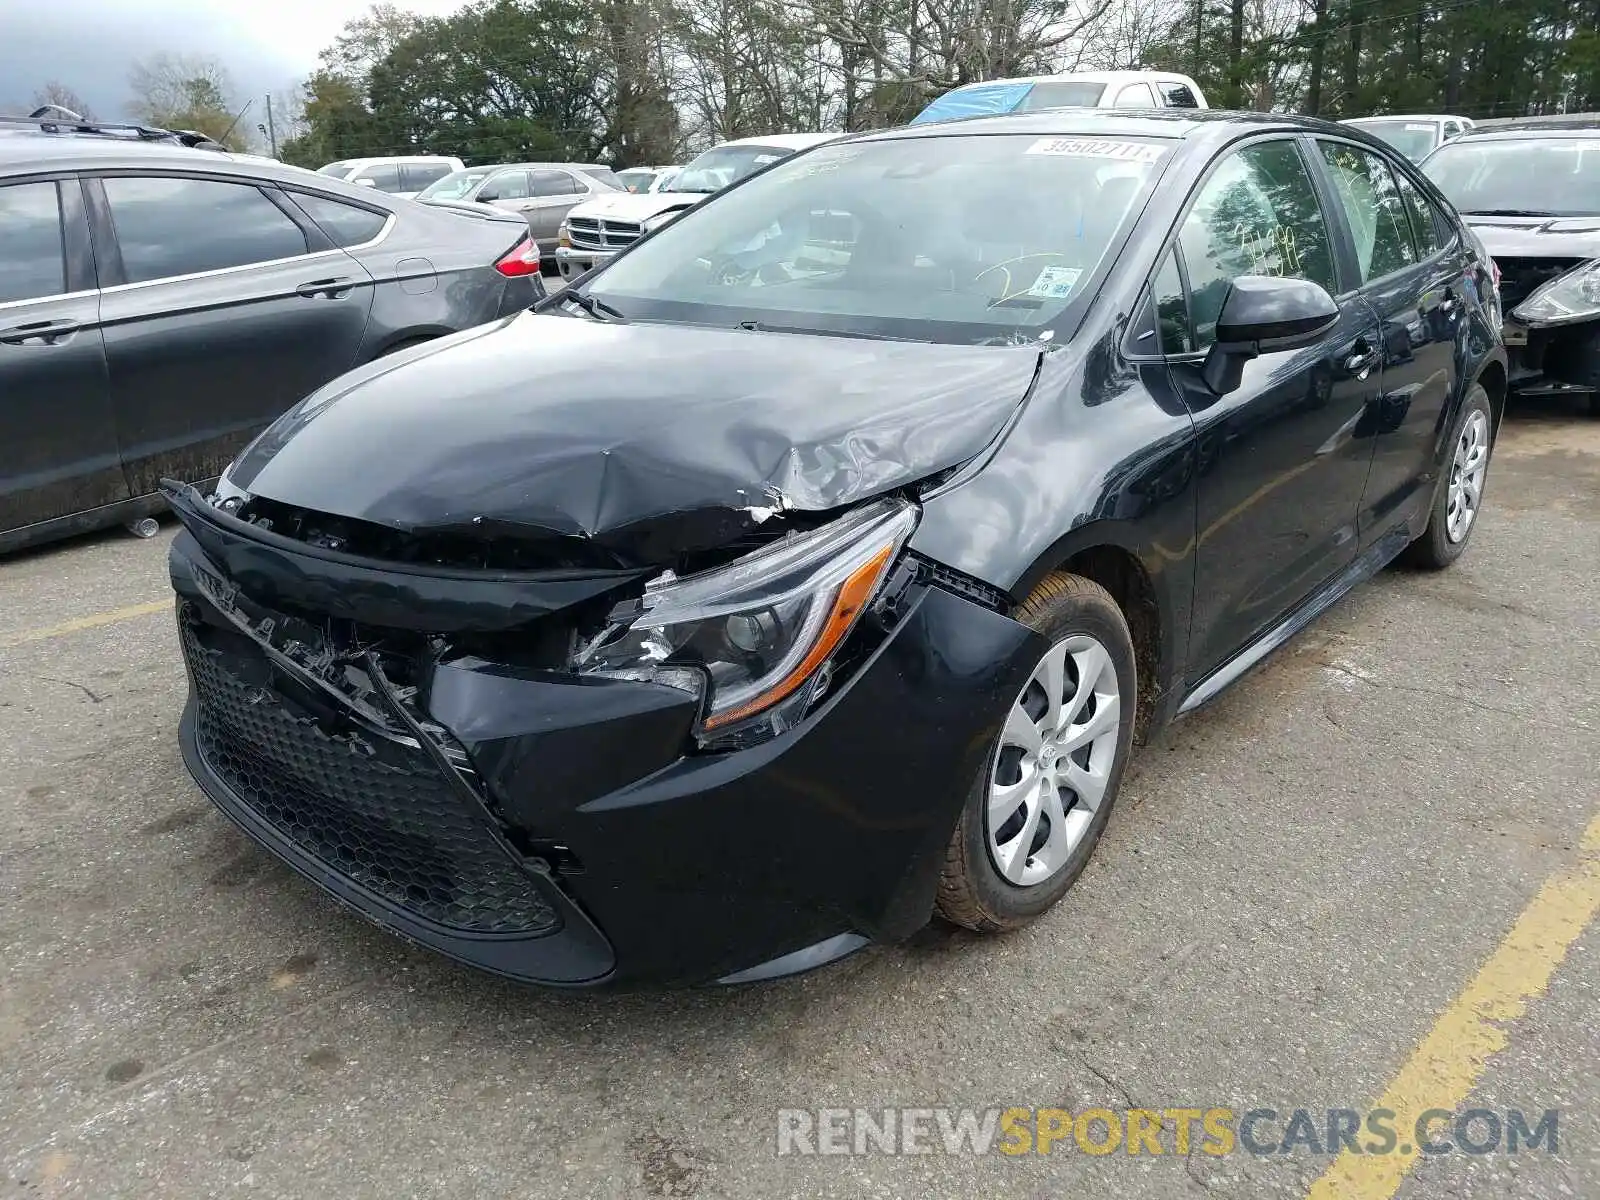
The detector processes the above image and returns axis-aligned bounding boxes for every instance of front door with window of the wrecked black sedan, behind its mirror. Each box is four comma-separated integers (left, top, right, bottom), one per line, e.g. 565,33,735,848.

1158,136,1379,683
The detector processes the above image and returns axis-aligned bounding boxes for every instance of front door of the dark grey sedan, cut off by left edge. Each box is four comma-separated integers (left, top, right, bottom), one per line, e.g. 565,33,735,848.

0,176,128,533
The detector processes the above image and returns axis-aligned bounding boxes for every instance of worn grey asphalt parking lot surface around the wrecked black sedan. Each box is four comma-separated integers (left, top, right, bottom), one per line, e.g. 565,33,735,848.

0,406,1600,1200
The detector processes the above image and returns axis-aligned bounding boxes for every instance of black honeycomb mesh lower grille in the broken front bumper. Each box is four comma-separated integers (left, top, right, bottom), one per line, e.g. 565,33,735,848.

181,616,558,933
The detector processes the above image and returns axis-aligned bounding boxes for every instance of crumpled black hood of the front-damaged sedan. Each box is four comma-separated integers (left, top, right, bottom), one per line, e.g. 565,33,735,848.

227,312,1040,549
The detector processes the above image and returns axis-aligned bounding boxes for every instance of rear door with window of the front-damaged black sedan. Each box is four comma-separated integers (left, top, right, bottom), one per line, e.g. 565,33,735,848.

1317,138,1467,544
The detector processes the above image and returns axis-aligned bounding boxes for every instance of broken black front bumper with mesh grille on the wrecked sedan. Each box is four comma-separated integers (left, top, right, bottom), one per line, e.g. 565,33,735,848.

170,493,1043,987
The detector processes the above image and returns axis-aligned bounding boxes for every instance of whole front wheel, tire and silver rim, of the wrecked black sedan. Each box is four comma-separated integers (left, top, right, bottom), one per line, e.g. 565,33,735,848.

938,574,1138,931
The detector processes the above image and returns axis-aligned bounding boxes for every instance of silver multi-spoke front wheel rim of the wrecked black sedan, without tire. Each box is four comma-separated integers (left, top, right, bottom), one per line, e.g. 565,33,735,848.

984,634,1122,888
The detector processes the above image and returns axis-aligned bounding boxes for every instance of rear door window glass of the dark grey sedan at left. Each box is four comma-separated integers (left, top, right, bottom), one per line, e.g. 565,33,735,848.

102,176,306,283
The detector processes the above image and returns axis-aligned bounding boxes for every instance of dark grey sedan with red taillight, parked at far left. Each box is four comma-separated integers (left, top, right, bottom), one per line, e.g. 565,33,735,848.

0,114,541,552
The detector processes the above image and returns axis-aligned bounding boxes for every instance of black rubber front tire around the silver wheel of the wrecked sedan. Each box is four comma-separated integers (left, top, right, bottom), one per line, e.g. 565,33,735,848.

938,573,1138,933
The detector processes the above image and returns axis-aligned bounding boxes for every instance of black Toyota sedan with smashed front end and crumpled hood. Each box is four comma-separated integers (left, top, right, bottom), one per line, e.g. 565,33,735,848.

168,110,1506,986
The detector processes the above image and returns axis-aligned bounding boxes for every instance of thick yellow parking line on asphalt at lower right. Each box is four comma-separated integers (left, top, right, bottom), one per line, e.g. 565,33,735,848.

1306,816,1600,1200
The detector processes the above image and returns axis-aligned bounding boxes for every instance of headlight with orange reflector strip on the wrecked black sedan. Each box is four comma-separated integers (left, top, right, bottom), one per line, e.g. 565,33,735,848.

573,501,917,733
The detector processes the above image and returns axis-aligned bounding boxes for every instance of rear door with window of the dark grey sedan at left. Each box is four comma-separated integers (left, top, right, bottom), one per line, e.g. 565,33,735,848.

91,173,373,496
